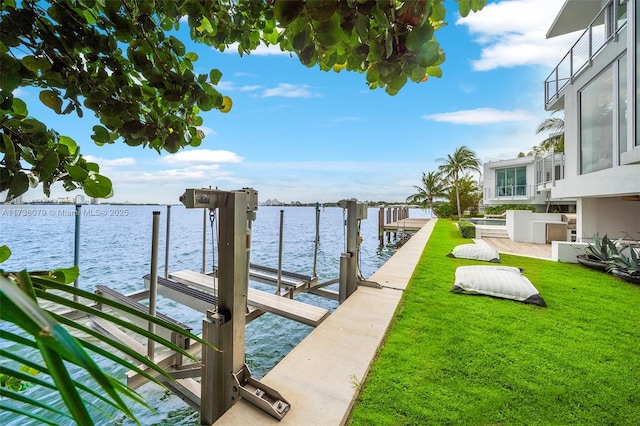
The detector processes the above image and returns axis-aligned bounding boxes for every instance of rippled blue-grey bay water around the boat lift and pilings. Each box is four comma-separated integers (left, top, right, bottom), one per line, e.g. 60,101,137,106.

0,205,425,425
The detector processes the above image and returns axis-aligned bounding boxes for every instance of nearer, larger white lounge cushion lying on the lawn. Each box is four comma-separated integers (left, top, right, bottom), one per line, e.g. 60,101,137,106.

451,265,547,306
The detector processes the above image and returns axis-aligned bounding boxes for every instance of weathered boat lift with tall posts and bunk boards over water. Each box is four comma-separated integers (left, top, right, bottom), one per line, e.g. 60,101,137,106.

74,188,376,425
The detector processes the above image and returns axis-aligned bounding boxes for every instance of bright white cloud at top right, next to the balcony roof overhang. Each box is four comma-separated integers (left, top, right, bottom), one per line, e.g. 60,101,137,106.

456,0,579,71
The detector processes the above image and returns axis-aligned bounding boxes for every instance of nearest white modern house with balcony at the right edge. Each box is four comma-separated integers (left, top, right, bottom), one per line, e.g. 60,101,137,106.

544,0,640,240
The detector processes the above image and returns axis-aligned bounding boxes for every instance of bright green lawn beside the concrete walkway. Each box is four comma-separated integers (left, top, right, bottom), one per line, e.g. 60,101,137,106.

349,220,640,425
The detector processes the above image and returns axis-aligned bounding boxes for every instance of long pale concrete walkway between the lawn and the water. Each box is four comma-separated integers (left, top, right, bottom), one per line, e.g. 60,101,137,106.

215,219,437,426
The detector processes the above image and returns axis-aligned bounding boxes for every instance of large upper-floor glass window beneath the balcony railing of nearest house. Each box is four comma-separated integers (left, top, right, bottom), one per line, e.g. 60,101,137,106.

580,67,614,174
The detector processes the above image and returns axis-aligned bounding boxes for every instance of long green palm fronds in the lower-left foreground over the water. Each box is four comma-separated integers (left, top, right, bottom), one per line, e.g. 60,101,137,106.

0,246,212,425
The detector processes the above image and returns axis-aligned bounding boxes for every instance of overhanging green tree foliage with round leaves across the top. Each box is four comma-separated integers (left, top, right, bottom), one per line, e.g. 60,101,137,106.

0,0,486,200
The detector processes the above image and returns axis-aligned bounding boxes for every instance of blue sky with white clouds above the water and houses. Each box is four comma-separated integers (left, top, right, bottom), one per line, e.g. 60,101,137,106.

17,0,580,204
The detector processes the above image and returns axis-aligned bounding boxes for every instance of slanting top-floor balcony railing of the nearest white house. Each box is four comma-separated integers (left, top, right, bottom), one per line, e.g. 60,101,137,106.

544,0,627,105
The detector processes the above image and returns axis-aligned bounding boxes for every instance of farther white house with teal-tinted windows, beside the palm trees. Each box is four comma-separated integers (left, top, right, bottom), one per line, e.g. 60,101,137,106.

482,153,576,212
